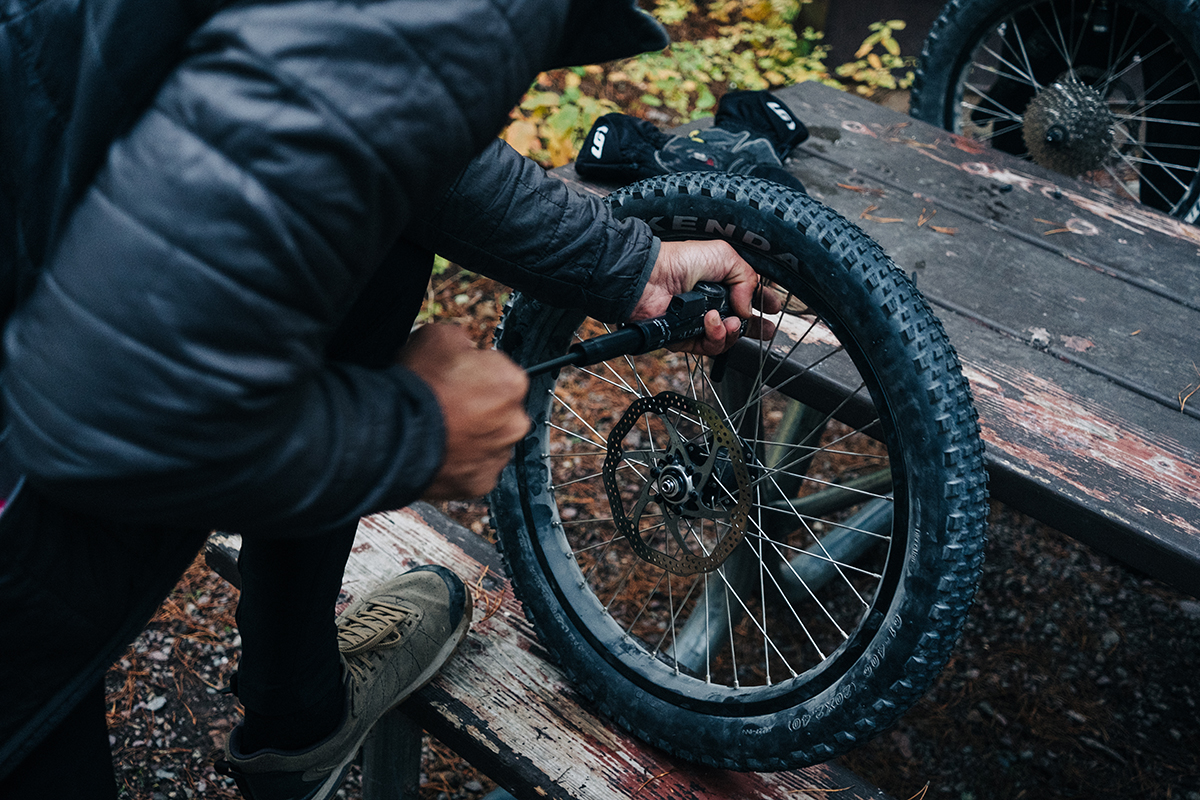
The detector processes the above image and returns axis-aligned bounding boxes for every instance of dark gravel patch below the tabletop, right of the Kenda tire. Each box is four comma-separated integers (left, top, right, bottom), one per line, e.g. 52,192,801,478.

845,505,1200,800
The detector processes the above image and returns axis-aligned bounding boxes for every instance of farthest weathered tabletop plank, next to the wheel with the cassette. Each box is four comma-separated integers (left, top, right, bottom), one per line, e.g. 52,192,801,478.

779,84,1200,303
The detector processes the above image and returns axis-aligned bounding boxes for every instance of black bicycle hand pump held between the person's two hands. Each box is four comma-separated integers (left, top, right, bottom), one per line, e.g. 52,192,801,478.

526,281,733,378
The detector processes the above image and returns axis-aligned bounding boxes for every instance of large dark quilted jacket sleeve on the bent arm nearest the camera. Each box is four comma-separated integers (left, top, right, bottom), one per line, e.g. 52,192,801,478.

2,0,580,533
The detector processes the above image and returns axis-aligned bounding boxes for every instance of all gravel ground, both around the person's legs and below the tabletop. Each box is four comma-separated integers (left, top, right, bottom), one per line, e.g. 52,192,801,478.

108,496,1200,800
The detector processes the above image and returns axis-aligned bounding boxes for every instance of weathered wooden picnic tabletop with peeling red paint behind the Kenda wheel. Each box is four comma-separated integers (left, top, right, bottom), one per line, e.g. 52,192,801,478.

558,83,1200,594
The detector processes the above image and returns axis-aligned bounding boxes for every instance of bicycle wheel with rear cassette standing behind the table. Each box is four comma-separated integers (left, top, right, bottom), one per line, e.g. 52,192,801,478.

911,0,1200,222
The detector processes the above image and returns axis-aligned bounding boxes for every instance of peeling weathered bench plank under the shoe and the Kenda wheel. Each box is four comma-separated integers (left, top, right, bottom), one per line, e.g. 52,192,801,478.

210,504,888,800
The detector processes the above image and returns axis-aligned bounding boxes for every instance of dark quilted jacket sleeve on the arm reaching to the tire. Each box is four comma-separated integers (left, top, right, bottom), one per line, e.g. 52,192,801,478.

404,139,659,321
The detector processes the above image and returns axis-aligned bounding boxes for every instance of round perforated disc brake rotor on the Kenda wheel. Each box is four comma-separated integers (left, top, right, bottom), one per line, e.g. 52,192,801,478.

604,392,751,575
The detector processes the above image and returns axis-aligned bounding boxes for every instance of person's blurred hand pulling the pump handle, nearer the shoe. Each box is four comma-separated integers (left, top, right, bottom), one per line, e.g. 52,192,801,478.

400,325,529,500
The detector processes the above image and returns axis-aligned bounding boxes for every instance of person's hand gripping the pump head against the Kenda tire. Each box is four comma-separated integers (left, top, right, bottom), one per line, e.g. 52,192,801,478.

630,239,782,355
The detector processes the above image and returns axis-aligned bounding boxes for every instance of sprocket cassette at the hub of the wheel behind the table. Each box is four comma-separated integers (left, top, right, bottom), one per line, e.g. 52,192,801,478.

1022,74,1116,178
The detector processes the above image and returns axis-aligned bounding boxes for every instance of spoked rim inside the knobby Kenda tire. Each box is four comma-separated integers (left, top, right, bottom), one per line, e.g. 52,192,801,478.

518,267,908,715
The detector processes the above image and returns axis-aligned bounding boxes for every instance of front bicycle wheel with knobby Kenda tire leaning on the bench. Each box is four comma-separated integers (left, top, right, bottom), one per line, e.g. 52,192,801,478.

491,173,986,770
